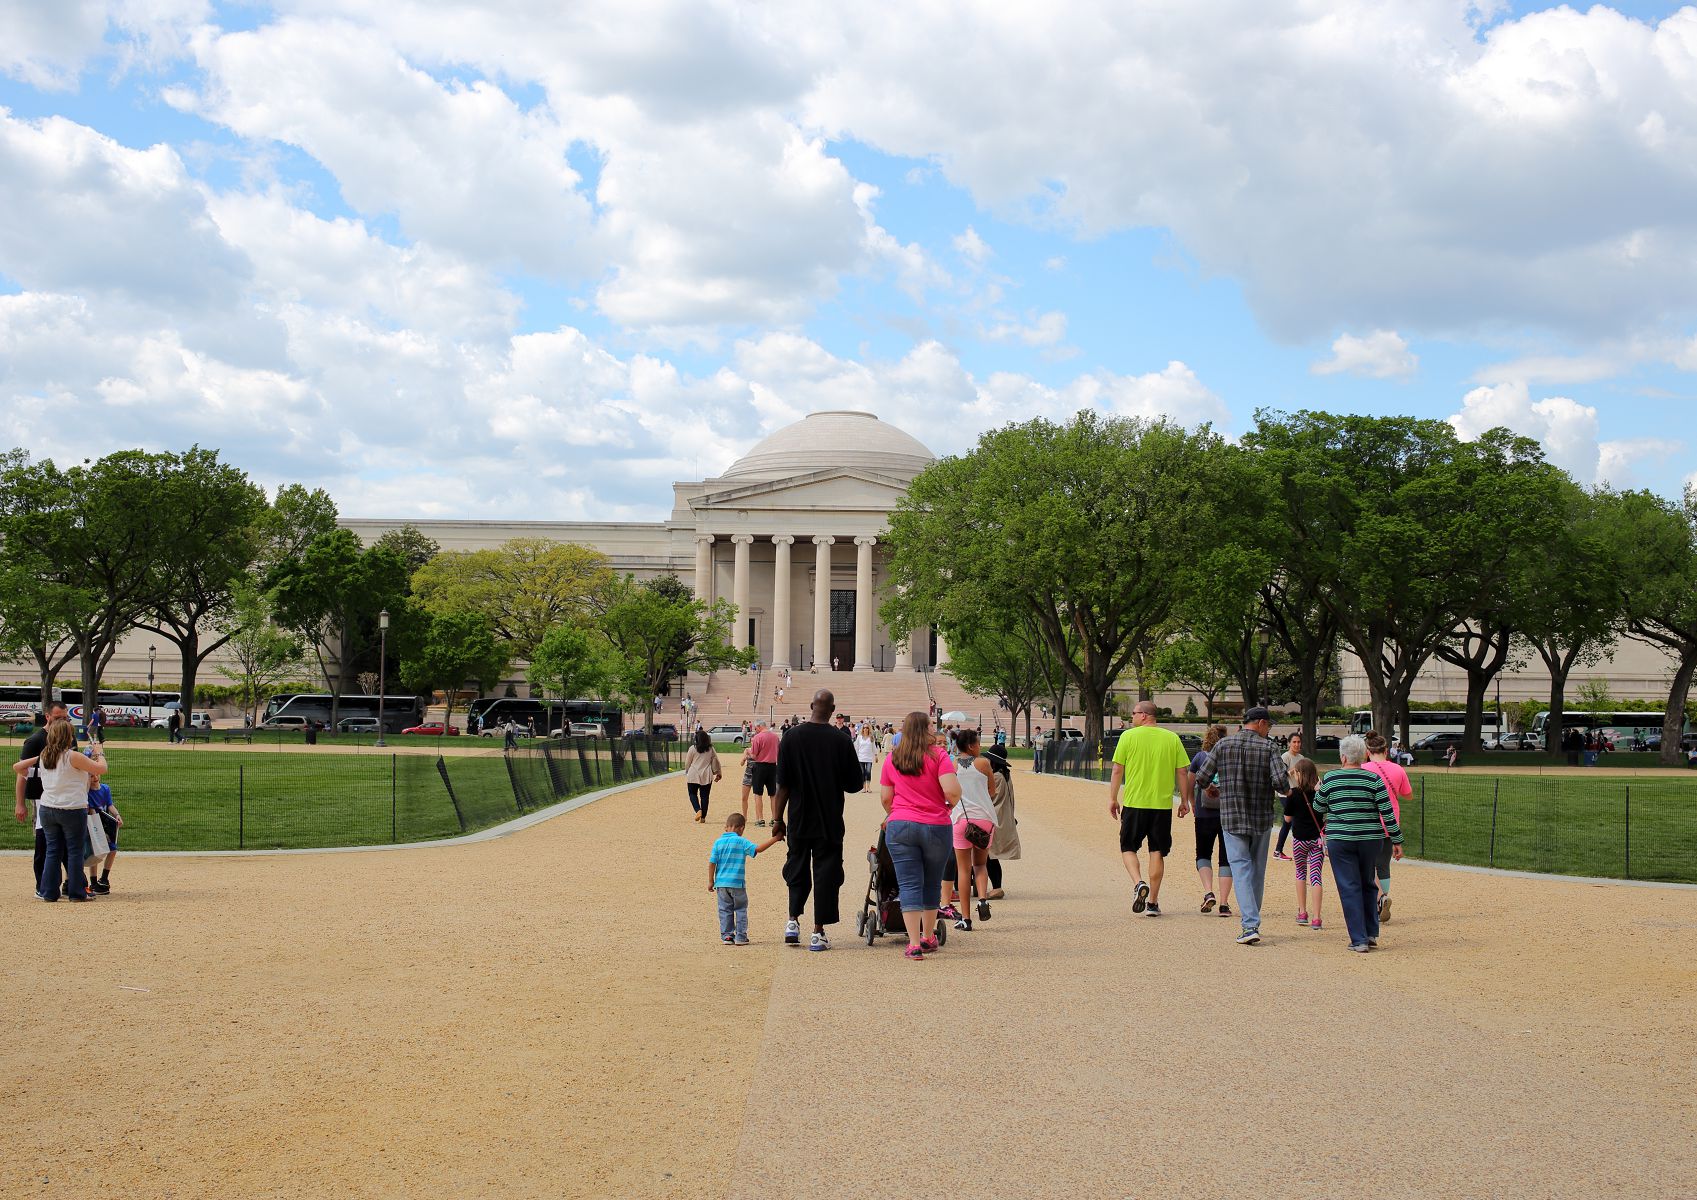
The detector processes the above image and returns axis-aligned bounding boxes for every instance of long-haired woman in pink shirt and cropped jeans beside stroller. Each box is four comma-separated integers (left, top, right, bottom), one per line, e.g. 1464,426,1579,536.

879,713,961,961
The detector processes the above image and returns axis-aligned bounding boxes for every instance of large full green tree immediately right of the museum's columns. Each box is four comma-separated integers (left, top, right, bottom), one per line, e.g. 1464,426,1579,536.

882,412,1224,743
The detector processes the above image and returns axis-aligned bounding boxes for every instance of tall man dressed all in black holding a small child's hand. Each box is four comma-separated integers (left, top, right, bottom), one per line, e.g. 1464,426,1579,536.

772,687,862,950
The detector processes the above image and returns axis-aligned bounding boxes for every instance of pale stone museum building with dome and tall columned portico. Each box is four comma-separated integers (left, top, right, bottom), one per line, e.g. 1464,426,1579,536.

343,412,947,670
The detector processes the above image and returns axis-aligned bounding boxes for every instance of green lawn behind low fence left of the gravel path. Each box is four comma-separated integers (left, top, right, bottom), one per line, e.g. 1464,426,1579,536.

0,743,682,850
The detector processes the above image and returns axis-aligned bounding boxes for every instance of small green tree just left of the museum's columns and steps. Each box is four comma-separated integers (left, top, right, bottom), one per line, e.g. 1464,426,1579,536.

596,575,759,733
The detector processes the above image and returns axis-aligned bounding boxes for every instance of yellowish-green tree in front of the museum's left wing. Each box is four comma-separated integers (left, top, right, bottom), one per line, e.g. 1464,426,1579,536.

412,538,613,659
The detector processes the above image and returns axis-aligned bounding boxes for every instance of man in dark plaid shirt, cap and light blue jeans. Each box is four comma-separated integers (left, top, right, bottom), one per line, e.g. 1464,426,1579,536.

1196,706,1290,945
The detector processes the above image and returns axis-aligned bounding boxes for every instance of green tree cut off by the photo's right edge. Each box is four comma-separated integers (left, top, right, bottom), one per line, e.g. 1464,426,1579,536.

1607,487,1697,765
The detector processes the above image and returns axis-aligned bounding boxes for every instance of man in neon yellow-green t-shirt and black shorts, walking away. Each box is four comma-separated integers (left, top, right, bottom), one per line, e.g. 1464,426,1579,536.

1108,699,1191,917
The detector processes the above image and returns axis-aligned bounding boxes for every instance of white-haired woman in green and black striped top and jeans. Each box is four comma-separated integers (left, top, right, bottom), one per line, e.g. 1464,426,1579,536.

1313,735,1402,954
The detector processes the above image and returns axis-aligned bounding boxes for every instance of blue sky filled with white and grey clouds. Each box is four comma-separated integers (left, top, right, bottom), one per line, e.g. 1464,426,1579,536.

0,0,1697,519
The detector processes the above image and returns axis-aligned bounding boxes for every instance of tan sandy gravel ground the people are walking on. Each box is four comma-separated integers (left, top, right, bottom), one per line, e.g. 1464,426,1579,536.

0,776,1697,1198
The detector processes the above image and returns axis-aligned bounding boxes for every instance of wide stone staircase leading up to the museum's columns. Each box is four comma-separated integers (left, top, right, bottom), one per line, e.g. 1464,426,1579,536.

675,667,1005,728
